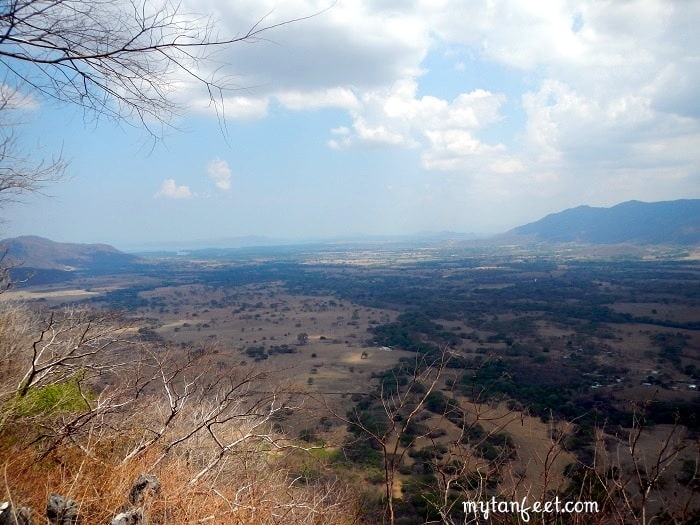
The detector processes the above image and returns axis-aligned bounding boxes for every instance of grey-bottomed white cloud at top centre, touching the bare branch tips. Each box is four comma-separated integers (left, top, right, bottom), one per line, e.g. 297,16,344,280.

176,0,430,114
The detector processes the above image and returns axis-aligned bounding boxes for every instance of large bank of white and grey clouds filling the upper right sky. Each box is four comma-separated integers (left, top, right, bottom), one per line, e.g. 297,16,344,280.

180,0,700,203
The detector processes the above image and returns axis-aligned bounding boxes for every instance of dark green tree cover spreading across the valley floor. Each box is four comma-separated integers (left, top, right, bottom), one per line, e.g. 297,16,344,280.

5,247,700,524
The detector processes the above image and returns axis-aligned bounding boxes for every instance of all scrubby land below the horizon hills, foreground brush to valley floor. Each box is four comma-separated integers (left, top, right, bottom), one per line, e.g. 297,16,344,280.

0,248,700,524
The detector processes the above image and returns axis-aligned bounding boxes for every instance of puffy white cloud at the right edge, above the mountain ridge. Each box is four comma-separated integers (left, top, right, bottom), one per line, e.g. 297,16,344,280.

523,75,700,174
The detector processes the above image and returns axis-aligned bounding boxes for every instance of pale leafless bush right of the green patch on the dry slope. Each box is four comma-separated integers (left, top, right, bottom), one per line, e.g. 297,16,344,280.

122,349,300,483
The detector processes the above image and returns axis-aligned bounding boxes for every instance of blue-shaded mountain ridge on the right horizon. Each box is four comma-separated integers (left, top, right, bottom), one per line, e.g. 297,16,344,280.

508,199,700,245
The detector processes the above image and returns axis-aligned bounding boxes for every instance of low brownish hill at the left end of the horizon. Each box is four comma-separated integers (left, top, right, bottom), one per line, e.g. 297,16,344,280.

0,235,139,271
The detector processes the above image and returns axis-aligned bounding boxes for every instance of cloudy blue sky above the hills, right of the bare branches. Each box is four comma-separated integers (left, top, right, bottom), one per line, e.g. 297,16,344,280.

0,0,700,249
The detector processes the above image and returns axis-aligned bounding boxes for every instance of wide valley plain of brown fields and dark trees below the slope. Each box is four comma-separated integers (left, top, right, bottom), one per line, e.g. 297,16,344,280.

4,244,700,520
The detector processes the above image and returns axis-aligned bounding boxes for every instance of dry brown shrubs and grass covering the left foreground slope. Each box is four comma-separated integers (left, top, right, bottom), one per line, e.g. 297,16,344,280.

0,304,358,525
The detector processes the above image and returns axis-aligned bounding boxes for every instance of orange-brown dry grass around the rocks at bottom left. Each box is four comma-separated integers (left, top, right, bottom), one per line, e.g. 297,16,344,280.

2,436,355,525
